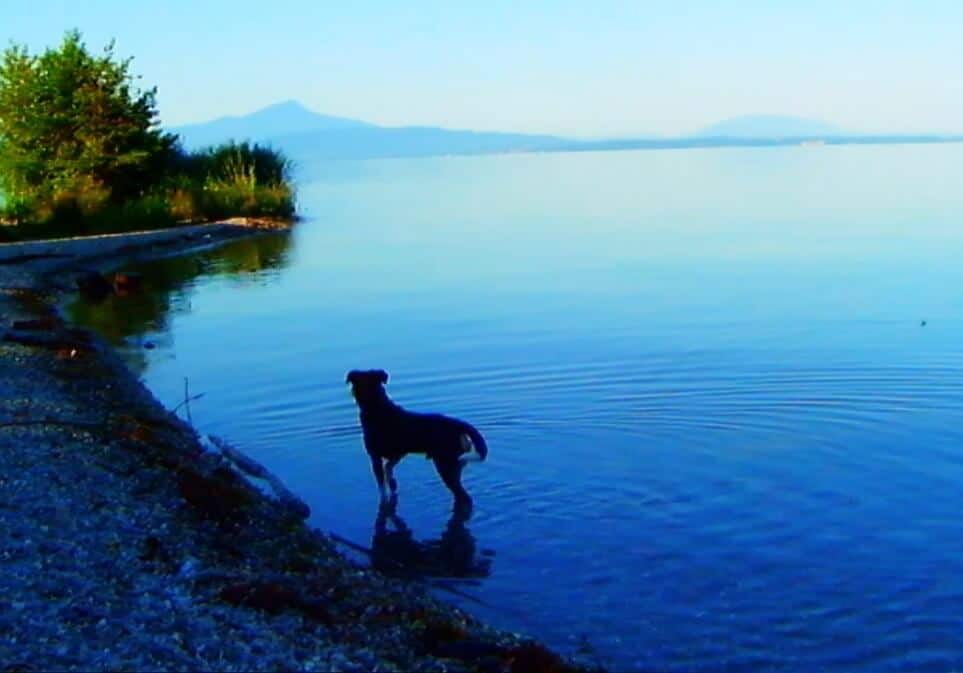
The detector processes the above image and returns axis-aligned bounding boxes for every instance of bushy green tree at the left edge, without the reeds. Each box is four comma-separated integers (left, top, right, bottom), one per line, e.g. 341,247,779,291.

0,31,176,219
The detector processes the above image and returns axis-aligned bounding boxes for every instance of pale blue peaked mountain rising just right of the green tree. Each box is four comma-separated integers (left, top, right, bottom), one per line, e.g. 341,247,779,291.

170,101,374,149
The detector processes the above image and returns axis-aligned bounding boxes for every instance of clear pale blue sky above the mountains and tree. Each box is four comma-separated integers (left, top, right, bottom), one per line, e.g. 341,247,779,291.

0,0,963,137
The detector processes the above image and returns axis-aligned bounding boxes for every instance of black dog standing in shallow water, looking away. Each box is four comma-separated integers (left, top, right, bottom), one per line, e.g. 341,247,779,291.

345,369,488,508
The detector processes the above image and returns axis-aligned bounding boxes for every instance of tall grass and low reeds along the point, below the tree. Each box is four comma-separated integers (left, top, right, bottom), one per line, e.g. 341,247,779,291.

0,142,295,241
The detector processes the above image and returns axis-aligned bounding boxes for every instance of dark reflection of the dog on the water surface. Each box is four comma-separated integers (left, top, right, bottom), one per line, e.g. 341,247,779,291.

371,497,492,579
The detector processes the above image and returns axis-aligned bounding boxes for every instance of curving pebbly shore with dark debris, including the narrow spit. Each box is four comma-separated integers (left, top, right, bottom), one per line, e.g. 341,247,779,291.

0,222,601,673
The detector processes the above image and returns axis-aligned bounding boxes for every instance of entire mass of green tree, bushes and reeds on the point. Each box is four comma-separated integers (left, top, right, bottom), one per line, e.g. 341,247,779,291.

0,31,294,241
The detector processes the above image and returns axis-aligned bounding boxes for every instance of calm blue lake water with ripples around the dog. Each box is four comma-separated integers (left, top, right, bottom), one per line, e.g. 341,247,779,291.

71,145,963,672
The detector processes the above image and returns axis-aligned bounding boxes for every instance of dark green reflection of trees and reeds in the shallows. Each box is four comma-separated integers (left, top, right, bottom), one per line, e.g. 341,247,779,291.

66,233,291,373
